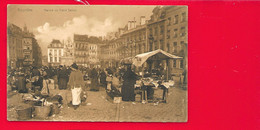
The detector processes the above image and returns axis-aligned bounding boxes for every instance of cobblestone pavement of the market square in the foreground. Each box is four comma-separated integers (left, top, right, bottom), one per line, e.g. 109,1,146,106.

7,87,187,122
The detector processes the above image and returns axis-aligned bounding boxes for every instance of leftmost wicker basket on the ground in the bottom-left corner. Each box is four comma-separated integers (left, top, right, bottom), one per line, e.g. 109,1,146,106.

16,107,32,120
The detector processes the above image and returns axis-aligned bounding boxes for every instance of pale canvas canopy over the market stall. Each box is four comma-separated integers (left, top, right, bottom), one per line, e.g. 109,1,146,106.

132,49,182,67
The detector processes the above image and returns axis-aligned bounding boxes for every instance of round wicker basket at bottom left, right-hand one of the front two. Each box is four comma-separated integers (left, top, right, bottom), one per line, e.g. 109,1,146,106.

35,106,51,119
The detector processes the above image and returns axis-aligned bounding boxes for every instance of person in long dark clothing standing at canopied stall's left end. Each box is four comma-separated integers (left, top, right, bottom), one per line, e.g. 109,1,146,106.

122,66,137,101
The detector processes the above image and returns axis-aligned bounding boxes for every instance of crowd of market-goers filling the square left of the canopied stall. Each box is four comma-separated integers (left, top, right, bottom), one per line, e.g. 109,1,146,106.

7,63,143,108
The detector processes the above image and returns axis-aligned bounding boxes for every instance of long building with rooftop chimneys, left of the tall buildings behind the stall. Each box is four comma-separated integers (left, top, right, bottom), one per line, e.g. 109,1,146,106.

102,16,146,66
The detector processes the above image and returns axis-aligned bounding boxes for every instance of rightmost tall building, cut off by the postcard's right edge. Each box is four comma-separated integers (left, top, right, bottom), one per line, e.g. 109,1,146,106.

164,6,188,82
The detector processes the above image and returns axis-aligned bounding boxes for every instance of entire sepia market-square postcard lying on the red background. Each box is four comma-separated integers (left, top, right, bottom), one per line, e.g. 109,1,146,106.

7,5,188,122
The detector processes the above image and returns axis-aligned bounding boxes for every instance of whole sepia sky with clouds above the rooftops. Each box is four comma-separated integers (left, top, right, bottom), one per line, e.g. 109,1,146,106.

7,5,155,54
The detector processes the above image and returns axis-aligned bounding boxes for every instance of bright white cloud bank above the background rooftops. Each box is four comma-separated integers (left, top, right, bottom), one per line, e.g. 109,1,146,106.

35,15,120,54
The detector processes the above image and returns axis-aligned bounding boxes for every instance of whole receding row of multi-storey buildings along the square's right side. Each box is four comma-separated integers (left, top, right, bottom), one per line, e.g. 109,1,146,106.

99,6,188,83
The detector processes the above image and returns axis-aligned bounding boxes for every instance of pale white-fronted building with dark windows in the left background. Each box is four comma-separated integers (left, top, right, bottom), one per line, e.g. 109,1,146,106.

48,39,64,66
